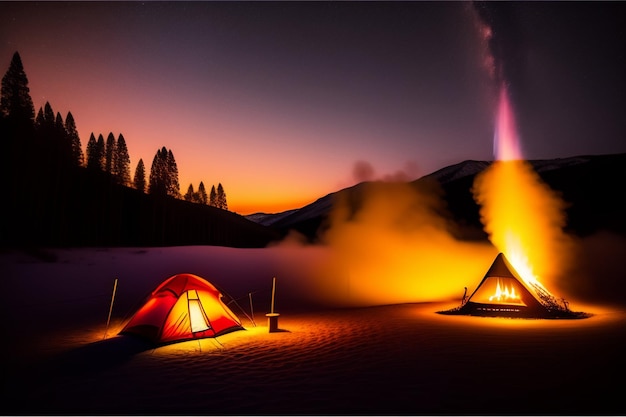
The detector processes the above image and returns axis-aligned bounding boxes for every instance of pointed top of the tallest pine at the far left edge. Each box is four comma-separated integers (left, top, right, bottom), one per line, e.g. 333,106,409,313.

0,52,35,126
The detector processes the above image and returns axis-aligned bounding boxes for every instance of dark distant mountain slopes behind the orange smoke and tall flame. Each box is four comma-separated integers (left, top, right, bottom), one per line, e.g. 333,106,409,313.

251,154,626,241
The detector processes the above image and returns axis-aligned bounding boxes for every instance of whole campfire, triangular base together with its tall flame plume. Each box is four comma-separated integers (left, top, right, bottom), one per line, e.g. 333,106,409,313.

442,85,587,318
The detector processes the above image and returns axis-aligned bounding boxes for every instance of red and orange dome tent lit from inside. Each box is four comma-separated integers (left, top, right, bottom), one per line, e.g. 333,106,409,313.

120,274,243,344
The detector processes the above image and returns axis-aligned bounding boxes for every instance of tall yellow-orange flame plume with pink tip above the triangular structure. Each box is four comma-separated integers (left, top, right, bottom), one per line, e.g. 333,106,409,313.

472,85,568,293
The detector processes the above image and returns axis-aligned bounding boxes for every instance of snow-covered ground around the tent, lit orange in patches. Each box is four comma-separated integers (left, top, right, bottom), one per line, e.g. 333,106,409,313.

0,236,626,415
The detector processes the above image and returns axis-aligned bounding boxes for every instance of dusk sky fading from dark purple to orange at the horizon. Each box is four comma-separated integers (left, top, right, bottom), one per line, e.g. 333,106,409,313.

0,2,626,214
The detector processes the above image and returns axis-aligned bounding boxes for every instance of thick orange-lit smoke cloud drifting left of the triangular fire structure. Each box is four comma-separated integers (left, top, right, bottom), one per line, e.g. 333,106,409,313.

315,181,496,306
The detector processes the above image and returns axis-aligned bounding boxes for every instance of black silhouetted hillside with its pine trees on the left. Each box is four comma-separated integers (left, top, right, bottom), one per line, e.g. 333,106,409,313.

0,52,276,246
